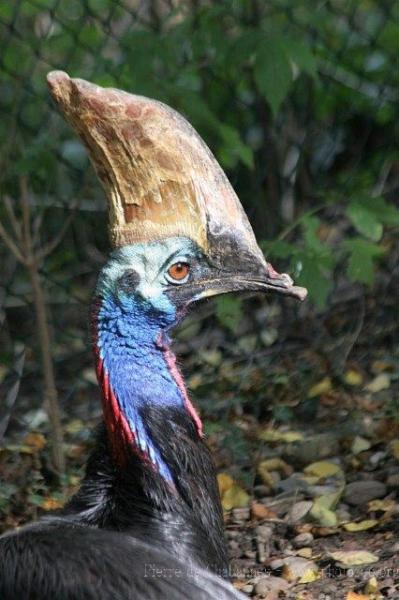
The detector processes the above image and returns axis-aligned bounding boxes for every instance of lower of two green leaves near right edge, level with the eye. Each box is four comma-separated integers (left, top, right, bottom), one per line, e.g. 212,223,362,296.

343,238,384,286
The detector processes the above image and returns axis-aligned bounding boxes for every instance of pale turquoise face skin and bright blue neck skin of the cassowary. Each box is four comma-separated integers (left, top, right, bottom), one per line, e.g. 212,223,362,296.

96,238,205,482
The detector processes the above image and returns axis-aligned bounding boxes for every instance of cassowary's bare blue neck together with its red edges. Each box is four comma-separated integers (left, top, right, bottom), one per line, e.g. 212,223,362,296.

92,296,202,484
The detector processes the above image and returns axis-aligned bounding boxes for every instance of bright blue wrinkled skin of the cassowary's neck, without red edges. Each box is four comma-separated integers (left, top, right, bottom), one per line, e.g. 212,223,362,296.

94,294,192,483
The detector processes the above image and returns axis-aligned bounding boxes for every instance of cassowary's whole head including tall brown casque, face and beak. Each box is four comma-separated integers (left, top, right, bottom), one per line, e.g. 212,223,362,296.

48,71,306,327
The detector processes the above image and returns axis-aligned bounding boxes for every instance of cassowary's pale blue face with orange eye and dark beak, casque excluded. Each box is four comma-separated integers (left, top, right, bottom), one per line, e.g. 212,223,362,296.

97,236,304,327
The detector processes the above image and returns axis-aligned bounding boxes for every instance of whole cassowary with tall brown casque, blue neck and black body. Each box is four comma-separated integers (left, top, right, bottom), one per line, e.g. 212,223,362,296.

0,72,305,600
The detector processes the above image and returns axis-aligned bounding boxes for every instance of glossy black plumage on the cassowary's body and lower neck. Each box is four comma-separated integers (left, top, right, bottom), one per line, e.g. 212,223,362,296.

0,407,241,600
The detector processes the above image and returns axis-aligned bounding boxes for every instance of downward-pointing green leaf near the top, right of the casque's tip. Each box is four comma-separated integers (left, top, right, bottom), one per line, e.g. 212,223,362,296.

254,35,293,115
